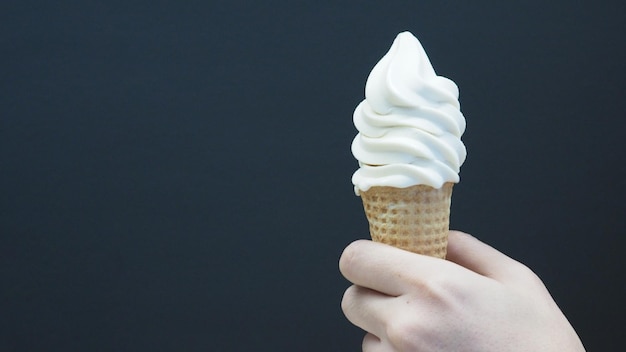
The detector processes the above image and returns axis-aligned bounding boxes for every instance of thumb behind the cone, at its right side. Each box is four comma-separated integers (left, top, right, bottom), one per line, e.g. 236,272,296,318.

446,231,523,281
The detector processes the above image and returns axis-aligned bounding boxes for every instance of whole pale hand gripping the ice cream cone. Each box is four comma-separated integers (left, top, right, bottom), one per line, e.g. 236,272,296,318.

339,231,585,352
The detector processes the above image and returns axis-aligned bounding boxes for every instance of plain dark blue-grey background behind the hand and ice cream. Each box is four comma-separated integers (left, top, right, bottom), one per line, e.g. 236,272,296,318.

0,0,626,351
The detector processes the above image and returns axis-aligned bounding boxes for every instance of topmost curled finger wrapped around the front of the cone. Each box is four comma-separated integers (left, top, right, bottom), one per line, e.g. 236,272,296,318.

339,240,446,296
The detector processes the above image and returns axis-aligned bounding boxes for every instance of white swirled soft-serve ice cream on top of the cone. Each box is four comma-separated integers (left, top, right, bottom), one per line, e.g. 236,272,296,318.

352,32,467,195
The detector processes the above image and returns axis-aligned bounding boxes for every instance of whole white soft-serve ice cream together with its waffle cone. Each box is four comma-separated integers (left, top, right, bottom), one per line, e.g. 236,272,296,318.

352,32,466,258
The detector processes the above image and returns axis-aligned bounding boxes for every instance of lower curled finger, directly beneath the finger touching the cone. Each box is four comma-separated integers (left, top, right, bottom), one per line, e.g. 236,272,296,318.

341,285,393,336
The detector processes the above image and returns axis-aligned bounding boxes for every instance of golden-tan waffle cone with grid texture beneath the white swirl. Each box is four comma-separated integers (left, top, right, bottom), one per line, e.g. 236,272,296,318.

361,183,454,258
